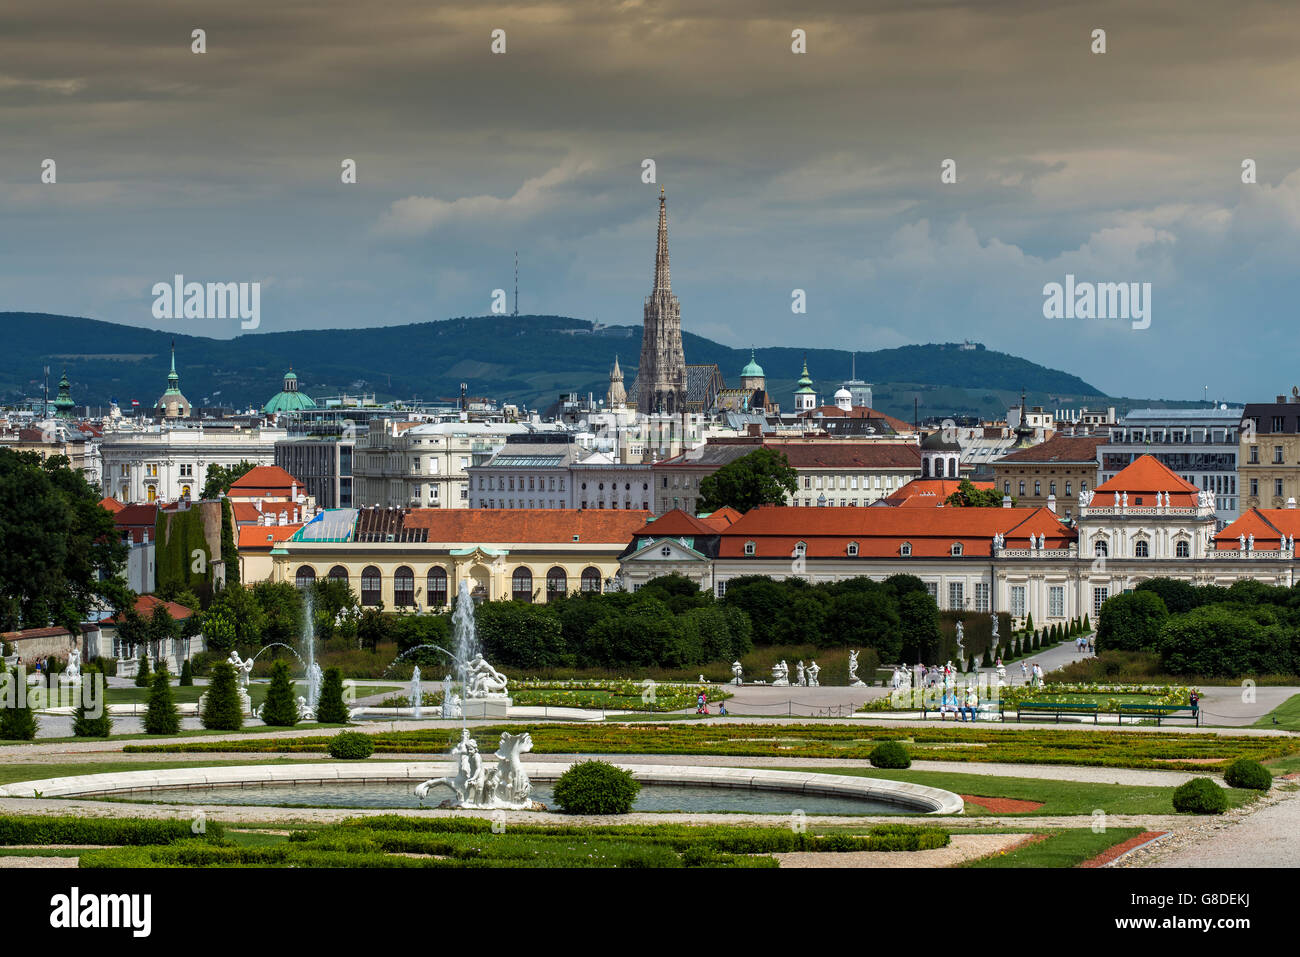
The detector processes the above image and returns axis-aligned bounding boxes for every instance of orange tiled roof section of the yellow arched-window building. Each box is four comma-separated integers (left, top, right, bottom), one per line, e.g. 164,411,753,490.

404,508,647,545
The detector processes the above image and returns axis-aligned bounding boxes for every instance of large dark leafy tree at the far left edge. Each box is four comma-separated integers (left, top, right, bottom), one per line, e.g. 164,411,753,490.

0,449,130,631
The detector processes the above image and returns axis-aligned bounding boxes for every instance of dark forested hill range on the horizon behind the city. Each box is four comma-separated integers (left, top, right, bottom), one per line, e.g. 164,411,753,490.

0,312,1115,420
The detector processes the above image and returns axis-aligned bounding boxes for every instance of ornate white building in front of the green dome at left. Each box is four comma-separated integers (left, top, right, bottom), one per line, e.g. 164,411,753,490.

99,424,286,505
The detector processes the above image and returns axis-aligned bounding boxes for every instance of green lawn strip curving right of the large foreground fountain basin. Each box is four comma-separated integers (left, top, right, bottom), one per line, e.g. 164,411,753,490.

776,767,1257,817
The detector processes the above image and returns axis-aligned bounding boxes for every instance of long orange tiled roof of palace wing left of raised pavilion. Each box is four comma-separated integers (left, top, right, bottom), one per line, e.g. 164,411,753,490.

718,506,1076,558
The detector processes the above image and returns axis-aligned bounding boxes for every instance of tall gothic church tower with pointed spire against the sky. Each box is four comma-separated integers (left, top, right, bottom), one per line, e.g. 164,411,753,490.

636,186,686,415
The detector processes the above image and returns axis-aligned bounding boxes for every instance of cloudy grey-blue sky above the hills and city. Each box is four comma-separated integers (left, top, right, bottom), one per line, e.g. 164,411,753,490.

0,0,1300,399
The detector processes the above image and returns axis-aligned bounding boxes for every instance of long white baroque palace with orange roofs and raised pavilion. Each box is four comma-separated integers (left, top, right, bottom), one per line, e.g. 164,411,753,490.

620,455,1300,624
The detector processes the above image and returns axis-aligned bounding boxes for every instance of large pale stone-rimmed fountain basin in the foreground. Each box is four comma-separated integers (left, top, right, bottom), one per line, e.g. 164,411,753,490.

0,761,963,814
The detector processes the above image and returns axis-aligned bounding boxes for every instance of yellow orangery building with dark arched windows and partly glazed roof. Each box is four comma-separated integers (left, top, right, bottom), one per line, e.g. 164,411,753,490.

267,508,650,609
